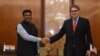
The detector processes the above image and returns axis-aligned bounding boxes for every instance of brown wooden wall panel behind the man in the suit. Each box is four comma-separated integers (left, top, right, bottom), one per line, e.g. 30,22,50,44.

75,0,100,50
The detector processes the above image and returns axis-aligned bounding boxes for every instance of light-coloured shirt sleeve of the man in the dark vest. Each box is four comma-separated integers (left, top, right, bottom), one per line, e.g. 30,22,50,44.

17,24,41,42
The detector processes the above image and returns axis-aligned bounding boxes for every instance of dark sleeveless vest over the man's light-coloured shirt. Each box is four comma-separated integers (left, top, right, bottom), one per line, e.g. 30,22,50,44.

17,21,38,56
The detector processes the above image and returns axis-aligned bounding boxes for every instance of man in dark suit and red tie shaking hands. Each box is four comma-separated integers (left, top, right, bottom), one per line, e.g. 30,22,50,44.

44,5,97,56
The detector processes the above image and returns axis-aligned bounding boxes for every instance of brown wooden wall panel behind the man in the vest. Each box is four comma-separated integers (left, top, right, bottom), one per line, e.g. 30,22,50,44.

0,0,43,44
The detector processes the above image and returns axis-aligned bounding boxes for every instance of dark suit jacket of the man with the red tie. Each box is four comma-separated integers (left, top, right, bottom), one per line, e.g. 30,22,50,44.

50,17,93,56
